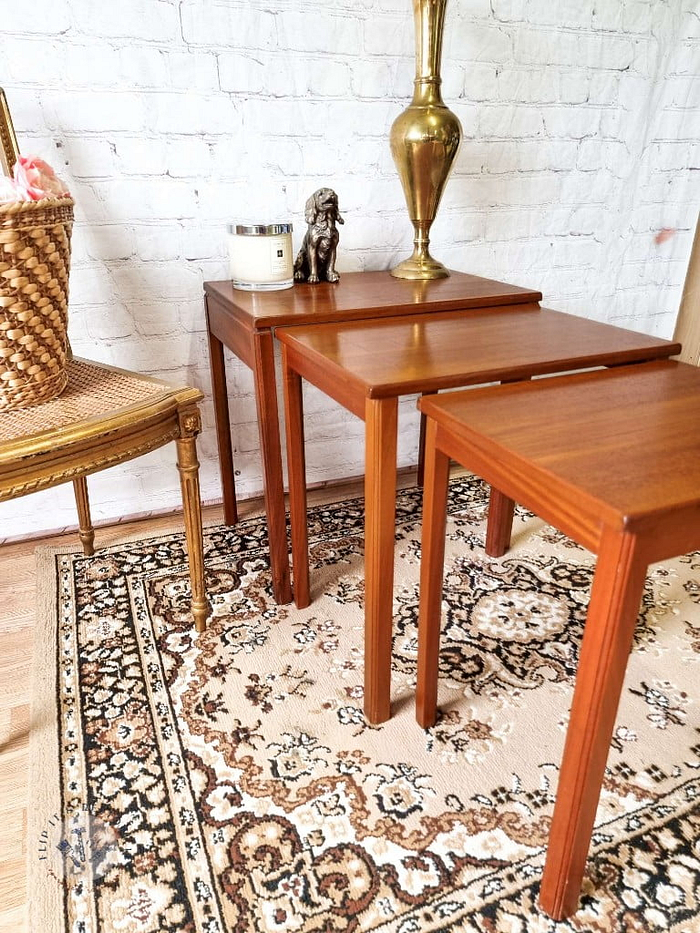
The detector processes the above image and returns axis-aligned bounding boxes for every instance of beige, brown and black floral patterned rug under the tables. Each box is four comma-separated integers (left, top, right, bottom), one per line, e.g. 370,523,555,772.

28,478,700,933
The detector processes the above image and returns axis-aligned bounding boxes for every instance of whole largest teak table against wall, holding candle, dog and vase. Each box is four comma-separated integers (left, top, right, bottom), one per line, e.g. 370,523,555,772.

204,272,542,603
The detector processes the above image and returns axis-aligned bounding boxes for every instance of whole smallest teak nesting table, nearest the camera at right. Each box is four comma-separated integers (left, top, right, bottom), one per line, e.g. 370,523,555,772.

417,361,700,920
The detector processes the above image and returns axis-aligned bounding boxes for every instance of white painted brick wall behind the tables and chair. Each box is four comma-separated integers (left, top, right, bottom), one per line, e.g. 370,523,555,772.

0,0,700,539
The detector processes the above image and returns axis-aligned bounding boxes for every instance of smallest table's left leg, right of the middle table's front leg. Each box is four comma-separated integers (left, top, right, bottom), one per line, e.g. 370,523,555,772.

416,419,450,729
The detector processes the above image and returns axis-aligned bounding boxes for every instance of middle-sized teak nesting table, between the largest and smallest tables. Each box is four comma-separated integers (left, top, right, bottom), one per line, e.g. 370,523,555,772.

276,302,680,723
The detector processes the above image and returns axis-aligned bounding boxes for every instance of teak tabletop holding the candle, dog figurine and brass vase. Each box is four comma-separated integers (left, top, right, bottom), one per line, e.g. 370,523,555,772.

204,272,542,330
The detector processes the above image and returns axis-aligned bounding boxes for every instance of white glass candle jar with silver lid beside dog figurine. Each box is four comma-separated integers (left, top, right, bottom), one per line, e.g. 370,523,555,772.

228,224,294,291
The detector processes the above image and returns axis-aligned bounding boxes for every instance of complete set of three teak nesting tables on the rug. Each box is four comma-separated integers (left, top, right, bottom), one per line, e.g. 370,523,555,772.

205,273,700,919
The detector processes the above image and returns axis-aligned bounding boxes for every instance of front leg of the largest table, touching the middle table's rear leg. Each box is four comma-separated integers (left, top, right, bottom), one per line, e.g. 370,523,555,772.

253,331,292,603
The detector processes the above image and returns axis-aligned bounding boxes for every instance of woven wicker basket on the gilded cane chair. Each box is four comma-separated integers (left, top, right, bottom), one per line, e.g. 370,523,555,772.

0,198,74,411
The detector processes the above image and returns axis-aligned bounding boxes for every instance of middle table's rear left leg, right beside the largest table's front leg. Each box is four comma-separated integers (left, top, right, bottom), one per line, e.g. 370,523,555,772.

282,346,310,609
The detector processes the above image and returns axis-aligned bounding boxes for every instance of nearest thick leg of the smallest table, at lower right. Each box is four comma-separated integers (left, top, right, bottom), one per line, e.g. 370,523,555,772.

540,529,647,920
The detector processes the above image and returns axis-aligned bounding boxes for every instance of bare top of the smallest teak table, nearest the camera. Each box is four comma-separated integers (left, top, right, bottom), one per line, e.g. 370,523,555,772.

419,361,700,530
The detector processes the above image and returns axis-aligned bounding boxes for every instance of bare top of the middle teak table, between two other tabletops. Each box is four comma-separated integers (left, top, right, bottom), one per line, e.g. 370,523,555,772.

275,304,681,398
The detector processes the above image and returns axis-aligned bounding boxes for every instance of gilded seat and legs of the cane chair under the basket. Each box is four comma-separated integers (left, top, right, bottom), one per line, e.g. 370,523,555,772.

0,359,208,631
